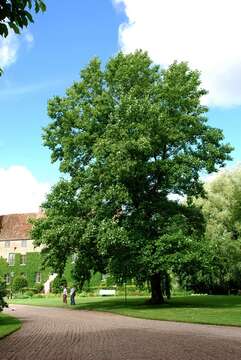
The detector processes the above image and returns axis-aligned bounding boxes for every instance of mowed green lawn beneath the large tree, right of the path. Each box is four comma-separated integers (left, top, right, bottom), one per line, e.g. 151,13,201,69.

10,295,241,326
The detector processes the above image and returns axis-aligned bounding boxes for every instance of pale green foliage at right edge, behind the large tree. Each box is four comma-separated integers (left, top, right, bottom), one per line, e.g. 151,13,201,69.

184,166,241,294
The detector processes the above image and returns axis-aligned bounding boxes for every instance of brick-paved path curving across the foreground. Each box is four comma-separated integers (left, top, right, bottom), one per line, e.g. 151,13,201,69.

0,305,241,360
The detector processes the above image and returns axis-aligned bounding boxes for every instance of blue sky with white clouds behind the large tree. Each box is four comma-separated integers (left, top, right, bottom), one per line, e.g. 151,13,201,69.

0,0,241,214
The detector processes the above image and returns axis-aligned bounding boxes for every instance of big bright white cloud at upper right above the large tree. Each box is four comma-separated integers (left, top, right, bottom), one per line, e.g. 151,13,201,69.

114,0,241,106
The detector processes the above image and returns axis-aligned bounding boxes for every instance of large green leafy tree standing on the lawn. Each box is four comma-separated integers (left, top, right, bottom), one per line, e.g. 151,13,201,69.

32,51,231,302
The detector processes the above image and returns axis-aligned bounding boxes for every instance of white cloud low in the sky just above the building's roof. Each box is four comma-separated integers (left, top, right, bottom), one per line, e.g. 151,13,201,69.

0,165,50,215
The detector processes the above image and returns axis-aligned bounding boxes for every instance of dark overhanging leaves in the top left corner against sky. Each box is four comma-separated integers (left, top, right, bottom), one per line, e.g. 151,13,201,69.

0,0,46,75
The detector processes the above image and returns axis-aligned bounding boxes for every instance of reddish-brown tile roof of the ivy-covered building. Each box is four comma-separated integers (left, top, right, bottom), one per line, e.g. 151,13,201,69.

0,213,40,240
